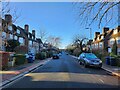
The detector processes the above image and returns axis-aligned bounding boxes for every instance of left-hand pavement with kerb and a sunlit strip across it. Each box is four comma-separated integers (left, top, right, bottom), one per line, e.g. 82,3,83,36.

0,58,51,87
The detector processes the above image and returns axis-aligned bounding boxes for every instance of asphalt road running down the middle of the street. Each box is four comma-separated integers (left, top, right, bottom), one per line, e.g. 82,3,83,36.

3,54,120,88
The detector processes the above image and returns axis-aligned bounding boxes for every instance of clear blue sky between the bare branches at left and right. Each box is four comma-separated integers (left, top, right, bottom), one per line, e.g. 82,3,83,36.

7,2,118,48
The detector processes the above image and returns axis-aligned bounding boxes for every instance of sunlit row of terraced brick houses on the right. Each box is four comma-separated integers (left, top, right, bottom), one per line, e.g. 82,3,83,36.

91,26,120,55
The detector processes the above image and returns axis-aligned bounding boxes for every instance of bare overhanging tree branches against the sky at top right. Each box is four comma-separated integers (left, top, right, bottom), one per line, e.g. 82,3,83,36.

73,0,120,28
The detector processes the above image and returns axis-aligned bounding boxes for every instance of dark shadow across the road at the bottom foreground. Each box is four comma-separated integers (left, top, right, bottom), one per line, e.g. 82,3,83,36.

5,76,118,89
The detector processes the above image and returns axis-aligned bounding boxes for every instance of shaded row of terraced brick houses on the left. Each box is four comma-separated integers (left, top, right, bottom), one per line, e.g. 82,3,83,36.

0,14,43,53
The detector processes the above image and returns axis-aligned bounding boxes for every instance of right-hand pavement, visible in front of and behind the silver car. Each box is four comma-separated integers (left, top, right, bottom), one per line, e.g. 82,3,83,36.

71,55,120,77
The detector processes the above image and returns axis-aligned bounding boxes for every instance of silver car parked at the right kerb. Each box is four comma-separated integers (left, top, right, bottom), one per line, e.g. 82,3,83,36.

78,53,102,68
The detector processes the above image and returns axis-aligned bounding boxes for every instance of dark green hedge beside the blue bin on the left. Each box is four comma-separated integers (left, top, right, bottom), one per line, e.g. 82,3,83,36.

14,54,26,65
